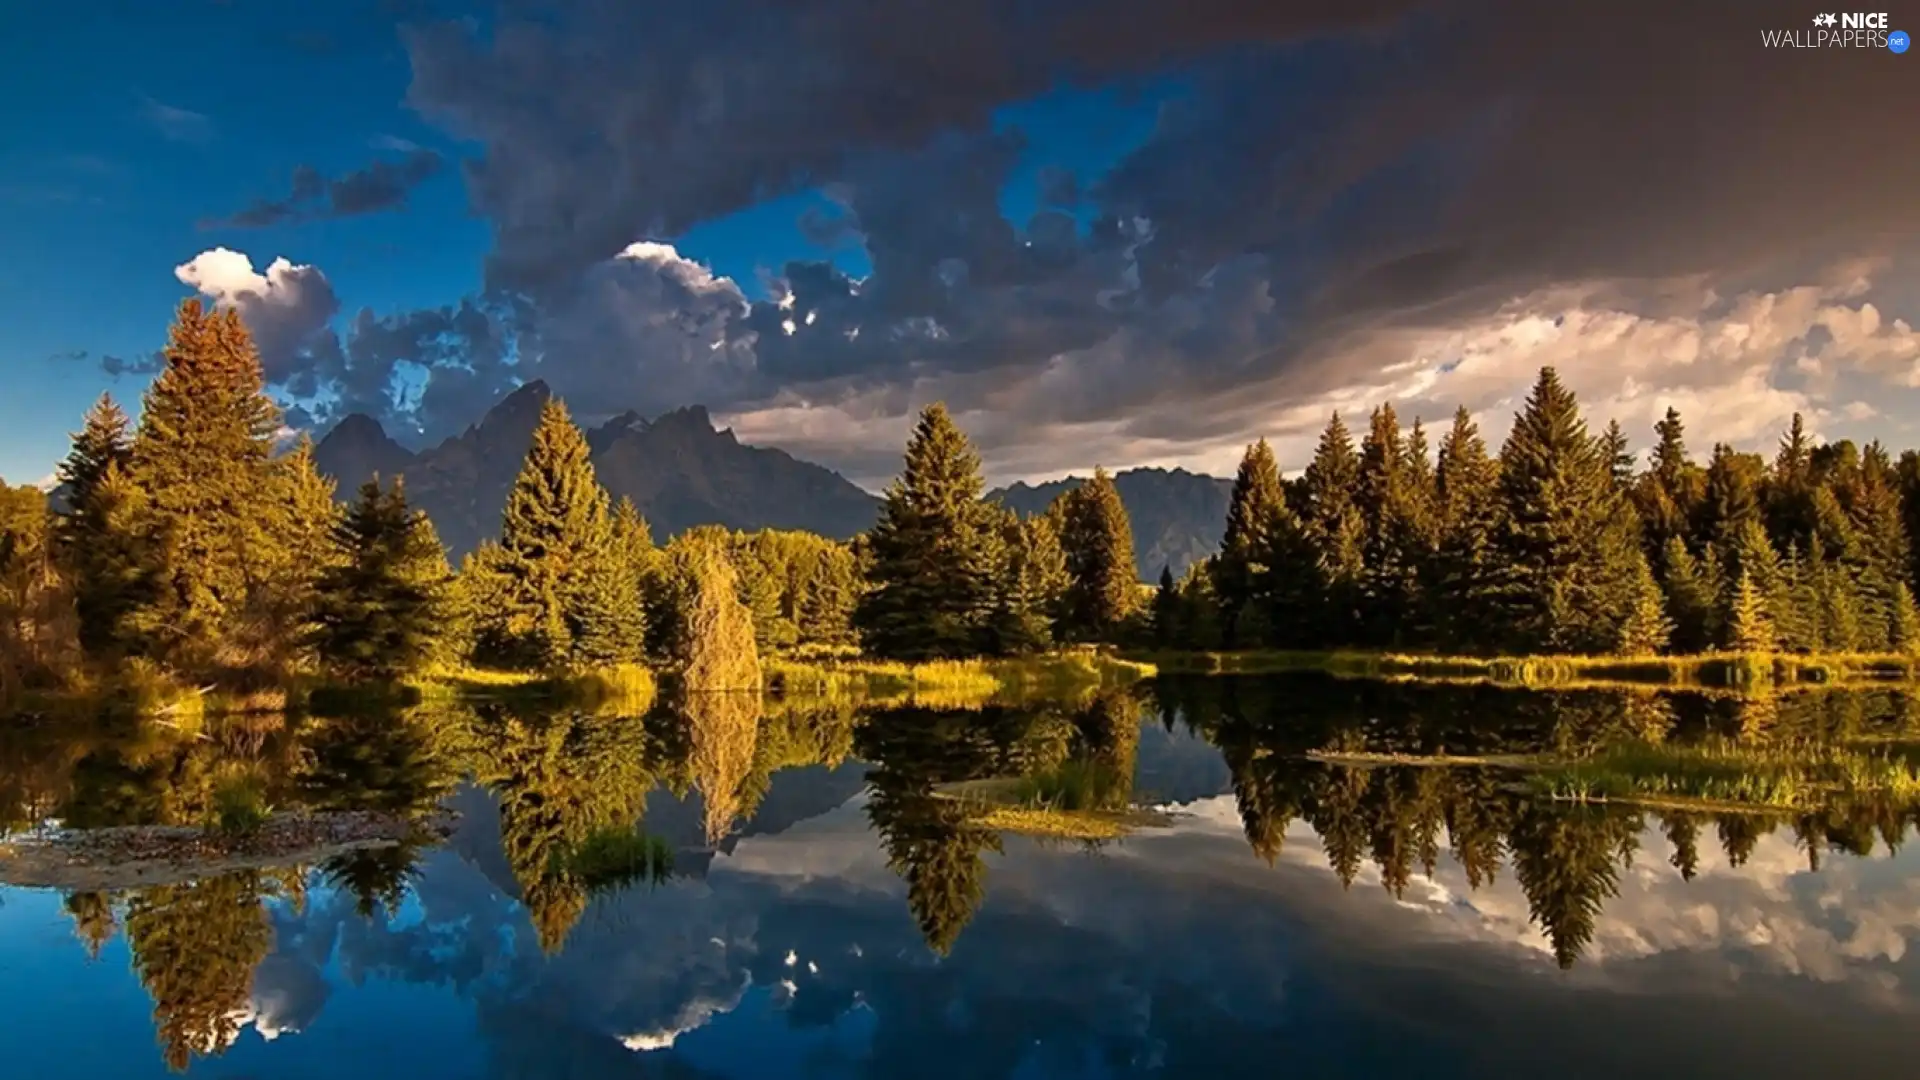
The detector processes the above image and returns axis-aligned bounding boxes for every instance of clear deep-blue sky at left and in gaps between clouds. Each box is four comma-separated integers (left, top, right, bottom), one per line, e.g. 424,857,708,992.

0,4,1158,482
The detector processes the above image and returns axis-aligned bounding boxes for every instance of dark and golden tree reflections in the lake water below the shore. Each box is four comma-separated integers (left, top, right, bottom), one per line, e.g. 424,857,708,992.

11,676,1920,1068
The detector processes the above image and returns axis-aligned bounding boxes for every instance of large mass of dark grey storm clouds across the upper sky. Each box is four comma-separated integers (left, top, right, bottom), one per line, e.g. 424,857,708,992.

217,0,1920,469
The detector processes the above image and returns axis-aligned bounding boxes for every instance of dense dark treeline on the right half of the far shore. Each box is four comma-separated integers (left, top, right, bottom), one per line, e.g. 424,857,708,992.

1154,369,1920,655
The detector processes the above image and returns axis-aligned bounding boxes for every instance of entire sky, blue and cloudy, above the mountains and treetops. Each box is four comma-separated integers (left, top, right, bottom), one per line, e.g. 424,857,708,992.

0,0,1920,482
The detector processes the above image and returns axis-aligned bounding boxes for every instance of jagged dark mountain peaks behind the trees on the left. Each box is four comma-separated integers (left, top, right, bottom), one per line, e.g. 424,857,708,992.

315,382,879,557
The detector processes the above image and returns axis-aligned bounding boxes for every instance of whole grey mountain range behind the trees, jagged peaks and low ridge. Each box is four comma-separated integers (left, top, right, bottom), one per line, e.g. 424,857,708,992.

313,380,1231,580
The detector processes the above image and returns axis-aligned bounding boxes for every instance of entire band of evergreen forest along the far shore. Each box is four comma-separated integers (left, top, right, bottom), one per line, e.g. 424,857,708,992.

0,302,1920,703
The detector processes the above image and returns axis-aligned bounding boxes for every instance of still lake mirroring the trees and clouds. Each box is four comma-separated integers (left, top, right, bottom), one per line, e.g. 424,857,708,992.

0,675,1920,1080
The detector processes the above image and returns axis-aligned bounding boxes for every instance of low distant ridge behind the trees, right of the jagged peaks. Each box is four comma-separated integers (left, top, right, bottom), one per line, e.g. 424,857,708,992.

987,469,1233,580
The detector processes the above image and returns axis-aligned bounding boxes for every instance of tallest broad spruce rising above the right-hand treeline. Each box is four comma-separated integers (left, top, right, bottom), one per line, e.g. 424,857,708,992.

1500,367,1636,651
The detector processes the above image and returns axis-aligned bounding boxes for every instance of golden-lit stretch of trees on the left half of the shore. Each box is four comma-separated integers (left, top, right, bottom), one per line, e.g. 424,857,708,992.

0,302,1139,701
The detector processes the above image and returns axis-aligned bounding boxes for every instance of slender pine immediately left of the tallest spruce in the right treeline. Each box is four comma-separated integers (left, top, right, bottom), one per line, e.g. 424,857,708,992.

1428,407,1500,648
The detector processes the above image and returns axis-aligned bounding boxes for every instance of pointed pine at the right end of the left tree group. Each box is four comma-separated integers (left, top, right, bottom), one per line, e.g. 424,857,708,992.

1060,469,1140,642
